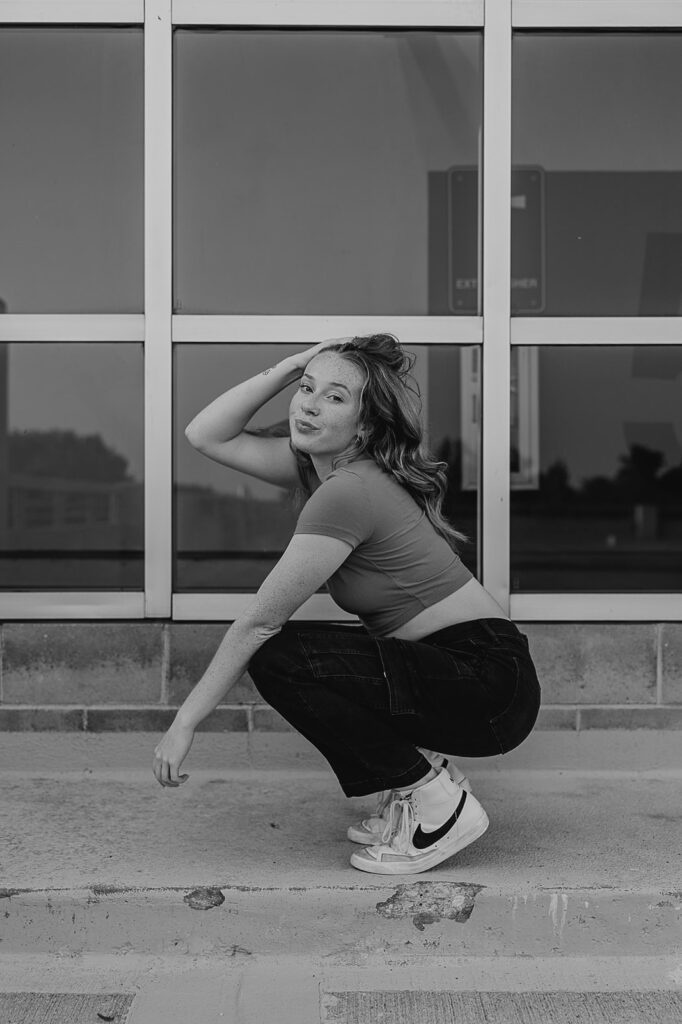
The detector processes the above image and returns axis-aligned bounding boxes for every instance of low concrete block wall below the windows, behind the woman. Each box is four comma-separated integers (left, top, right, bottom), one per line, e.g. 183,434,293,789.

0,622,682,732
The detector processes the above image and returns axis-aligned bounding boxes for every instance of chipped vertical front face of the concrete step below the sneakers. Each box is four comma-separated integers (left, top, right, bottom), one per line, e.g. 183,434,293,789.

0,878,682,957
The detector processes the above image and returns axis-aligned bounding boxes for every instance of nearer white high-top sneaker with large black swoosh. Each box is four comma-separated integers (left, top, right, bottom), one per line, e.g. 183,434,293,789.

350,769,489,874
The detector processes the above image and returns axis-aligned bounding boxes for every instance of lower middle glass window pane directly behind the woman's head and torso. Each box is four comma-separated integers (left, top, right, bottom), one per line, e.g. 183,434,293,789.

174,344,479,592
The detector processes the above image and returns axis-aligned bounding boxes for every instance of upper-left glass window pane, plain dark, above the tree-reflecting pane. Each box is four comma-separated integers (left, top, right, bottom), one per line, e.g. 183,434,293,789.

0,27,144,313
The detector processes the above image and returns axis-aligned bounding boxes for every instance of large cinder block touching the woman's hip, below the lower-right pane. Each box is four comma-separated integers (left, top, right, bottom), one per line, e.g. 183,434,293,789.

520,623,656,705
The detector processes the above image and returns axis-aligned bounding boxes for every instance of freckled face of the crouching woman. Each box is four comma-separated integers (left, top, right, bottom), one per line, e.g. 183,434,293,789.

289,352,365,460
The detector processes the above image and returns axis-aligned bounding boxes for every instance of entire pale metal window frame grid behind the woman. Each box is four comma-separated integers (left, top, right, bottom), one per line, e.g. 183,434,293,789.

0,0,682,622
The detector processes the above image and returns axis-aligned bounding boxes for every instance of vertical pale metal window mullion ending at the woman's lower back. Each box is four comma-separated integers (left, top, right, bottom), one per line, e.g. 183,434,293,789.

481,0,511,609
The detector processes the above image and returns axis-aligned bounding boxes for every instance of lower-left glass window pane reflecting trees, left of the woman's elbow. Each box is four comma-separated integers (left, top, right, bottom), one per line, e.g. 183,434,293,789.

0,343,144,590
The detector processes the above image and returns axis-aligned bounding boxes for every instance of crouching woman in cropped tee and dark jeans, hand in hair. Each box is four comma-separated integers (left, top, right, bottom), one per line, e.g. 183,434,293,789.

154,335,540,874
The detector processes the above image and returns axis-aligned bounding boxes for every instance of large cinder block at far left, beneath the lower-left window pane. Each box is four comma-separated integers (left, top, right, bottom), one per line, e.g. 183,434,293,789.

3,623,162,705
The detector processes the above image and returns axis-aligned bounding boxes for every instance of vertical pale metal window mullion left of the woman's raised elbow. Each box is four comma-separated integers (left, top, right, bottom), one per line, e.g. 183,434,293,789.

144,0,173,617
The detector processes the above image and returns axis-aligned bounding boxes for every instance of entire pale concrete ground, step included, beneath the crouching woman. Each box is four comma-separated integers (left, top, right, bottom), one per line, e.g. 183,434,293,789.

0,732,682,1024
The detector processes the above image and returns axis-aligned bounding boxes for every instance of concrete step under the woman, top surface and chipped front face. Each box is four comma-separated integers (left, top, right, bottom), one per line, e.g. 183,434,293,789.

0,736,682,959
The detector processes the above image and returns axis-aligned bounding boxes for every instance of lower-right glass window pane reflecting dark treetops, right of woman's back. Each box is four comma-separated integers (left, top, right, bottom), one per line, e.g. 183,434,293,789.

511,345,682,593
